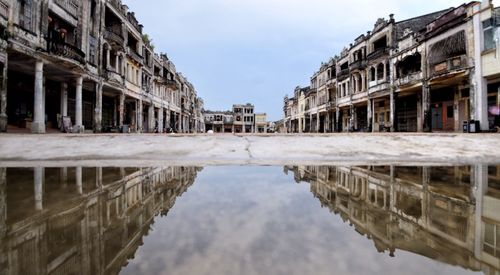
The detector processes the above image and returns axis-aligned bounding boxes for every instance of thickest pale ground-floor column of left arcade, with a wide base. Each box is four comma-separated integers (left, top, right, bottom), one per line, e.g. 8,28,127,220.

31,61,45,134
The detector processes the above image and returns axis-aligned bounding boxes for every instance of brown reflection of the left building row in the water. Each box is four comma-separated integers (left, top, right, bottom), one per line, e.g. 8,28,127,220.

0,167,201,274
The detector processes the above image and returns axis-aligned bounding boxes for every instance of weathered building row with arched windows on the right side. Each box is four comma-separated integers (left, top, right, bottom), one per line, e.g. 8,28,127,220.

283,1,500,133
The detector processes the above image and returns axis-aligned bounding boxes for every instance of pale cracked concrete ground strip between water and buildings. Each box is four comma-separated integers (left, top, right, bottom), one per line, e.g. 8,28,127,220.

0,134,500,166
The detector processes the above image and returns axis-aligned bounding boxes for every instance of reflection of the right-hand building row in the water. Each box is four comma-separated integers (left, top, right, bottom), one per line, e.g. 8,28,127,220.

284,165,500,274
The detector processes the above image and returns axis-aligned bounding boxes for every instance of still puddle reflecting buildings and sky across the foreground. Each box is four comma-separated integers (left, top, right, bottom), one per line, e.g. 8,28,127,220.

0,165,500,275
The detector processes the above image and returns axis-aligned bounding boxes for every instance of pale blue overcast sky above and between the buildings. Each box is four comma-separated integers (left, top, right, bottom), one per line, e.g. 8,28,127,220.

124,0,500,120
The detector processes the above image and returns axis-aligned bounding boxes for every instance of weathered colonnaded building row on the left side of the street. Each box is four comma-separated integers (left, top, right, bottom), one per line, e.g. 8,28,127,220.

0,0,203,133
